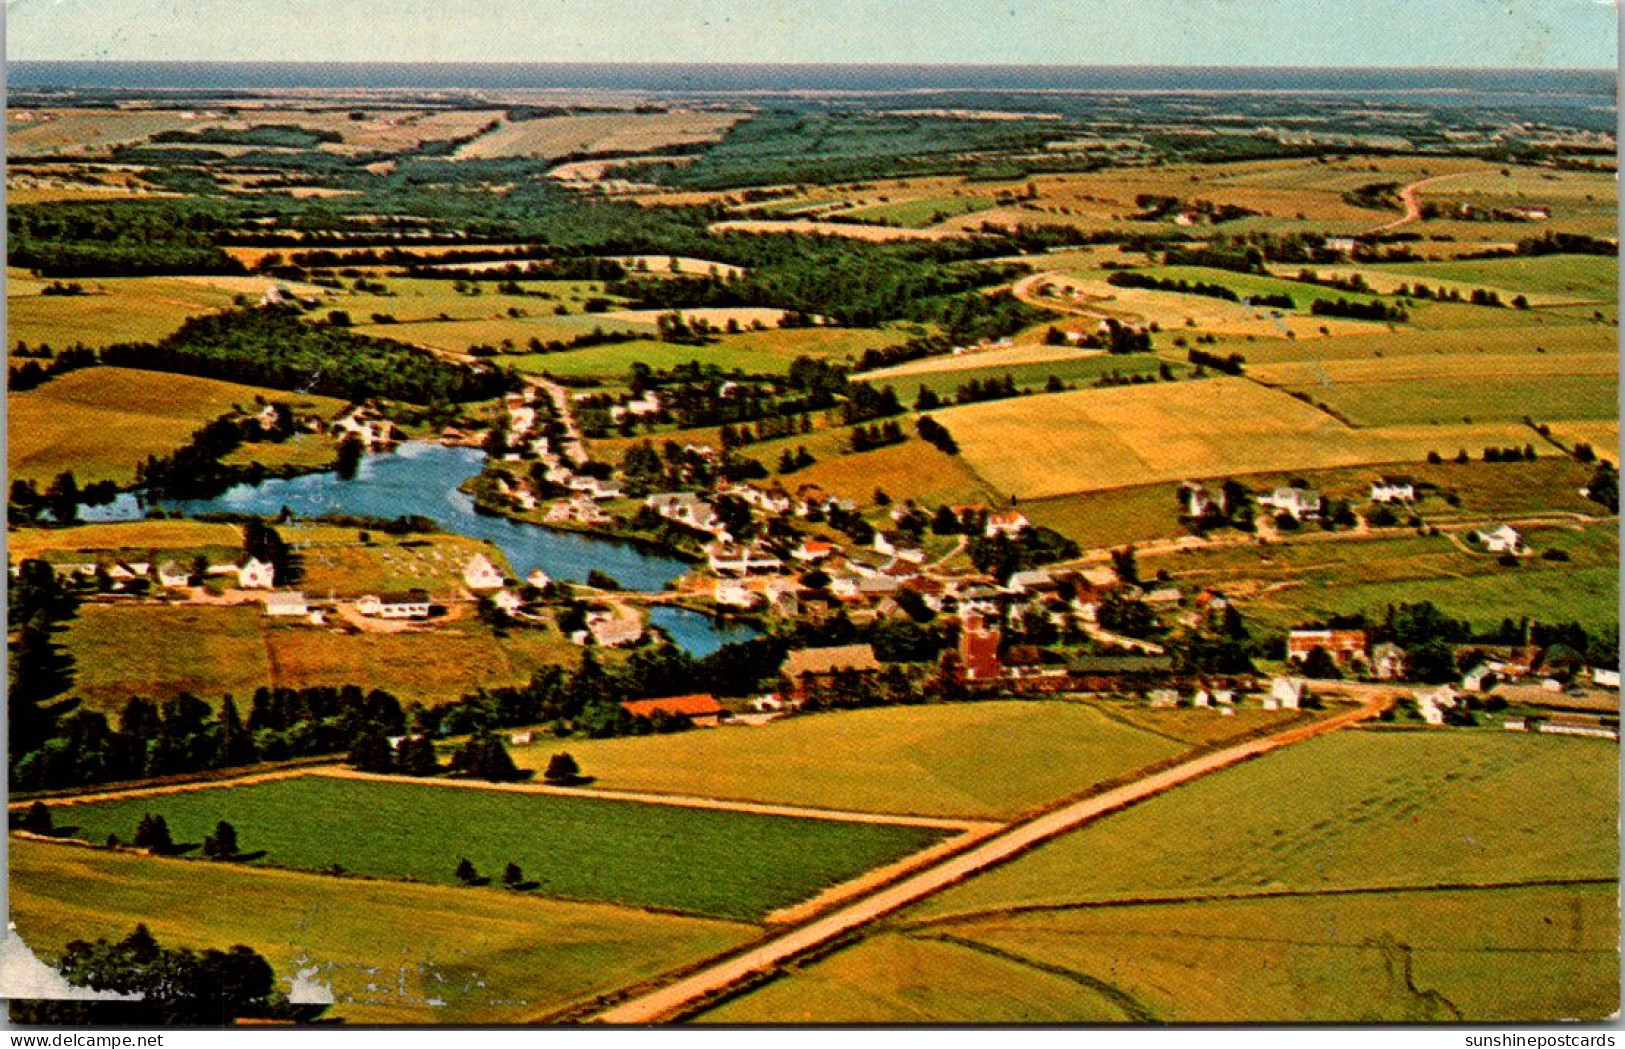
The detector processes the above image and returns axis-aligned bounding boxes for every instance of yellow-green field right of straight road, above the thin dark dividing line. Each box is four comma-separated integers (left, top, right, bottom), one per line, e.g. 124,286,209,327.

918,729,1619,919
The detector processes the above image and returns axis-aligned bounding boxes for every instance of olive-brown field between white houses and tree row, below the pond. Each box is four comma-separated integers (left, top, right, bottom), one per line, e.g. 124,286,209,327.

59,594,580,710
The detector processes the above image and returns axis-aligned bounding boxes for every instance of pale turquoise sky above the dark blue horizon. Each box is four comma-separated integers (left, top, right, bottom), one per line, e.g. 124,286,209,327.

5,0,1619,68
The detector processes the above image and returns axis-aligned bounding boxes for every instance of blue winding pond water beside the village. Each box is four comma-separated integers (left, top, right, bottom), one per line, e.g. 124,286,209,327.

80,442,757,656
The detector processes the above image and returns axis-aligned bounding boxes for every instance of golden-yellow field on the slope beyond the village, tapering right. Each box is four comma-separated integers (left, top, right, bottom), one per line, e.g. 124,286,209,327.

936,378,1531,500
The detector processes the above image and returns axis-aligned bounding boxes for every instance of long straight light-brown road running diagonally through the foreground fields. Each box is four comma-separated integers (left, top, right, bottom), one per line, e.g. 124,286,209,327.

595,689,1393,1023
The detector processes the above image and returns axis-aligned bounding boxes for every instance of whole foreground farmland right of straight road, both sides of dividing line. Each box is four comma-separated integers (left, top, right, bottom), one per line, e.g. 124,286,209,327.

700,729,1619,1023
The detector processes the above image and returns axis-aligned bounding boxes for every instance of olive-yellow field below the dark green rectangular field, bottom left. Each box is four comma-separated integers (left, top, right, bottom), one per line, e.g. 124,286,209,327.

10,840,754,1025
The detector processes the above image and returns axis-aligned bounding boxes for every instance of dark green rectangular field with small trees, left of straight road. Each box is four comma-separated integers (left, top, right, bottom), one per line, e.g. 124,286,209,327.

44,776,943,921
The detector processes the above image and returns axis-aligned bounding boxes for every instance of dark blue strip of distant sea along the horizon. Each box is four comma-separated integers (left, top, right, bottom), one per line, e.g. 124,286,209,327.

7,62,1617,106
